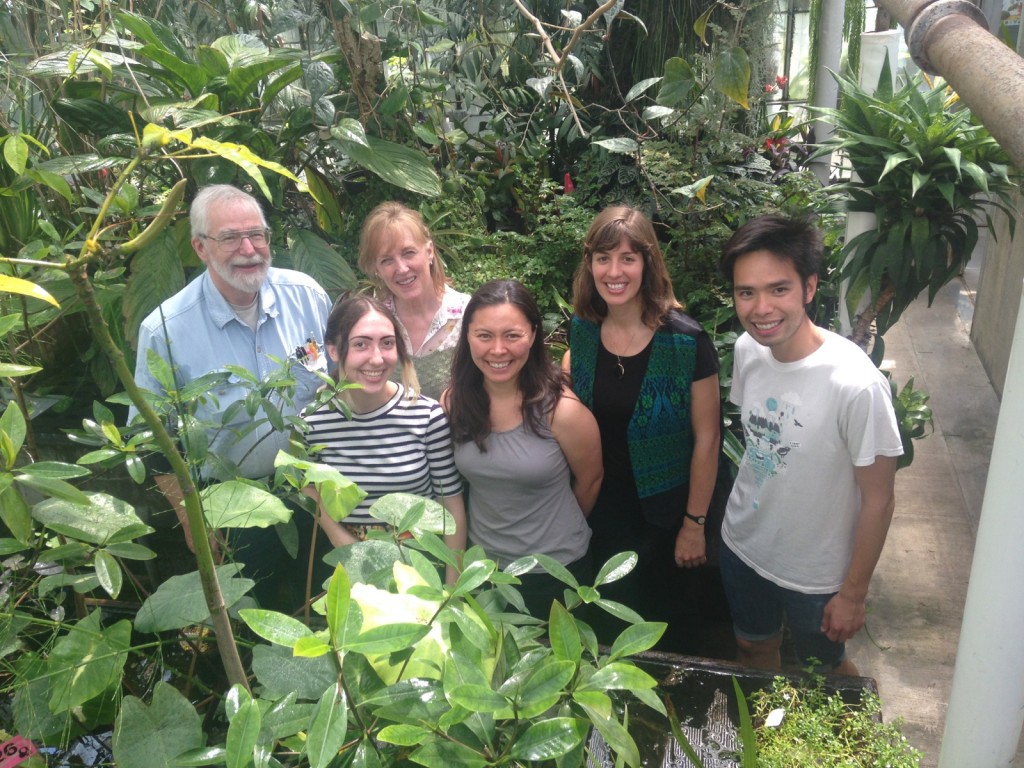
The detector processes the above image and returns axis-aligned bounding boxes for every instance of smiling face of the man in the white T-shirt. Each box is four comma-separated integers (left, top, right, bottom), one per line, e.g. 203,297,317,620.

732,251,821,362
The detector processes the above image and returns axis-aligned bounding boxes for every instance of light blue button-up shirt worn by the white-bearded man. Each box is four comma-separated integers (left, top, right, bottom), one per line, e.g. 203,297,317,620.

129,267,331,479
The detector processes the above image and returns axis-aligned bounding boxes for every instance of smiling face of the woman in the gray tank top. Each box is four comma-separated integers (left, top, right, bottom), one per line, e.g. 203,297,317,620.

467,304,537,384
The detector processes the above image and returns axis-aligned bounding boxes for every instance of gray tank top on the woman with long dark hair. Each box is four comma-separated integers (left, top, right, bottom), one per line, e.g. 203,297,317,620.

455,415,590,567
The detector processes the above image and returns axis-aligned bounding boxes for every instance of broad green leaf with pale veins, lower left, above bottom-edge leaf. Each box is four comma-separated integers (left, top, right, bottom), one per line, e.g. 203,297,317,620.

46,610,131,713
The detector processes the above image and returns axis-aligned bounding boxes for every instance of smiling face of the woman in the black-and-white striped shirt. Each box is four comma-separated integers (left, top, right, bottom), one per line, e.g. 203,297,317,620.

327,310,398,403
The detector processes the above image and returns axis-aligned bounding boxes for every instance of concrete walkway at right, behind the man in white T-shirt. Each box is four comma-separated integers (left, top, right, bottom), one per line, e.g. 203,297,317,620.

849,269,1024,768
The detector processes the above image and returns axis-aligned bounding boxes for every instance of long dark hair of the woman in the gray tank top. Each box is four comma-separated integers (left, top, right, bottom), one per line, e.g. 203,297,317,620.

447,280,565,451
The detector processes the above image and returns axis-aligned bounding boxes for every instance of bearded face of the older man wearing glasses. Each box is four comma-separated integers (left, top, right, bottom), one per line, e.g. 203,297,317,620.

191,199,271,306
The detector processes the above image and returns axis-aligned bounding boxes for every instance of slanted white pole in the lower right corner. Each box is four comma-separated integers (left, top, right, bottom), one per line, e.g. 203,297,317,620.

939,284,1024,768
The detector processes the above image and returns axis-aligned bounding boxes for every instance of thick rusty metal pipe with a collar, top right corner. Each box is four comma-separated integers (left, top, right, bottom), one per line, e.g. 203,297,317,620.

879,0,1024,168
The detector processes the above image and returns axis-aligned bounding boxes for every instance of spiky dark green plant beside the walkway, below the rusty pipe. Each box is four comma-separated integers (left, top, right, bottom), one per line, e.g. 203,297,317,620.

820,70,1014,341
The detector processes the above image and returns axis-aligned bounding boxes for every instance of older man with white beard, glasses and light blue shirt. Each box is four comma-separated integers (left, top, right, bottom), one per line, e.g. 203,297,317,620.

130,184,331,606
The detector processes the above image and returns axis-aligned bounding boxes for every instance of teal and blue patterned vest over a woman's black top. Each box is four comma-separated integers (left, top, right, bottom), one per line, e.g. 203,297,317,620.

569,310,701,499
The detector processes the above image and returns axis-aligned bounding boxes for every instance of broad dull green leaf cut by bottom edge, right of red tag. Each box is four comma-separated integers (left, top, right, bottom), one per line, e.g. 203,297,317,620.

113,682,205,768
